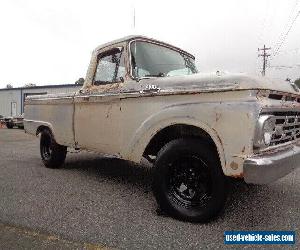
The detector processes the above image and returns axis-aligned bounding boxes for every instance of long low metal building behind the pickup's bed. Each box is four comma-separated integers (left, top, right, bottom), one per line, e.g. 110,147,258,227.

0,84,82,117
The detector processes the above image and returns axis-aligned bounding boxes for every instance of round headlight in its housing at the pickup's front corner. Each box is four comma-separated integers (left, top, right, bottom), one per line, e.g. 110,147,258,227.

254,115,275,149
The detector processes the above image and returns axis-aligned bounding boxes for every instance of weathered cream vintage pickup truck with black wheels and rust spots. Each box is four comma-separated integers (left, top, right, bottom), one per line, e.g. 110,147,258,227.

24,36,300,222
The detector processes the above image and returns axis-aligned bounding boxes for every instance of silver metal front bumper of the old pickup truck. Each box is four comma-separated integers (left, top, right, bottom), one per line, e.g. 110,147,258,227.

244,144,300,184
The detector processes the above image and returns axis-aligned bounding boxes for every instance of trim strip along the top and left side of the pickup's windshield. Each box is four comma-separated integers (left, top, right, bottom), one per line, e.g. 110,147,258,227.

128,38,195,80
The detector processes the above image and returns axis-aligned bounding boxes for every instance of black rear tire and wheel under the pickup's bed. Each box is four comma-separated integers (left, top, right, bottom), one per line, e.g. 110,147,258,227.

40,129,67,168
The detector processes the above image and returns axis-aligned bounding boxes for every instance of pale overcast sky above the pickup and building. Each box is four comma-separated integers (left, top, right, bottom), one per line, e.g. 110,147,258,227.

0,0,300,88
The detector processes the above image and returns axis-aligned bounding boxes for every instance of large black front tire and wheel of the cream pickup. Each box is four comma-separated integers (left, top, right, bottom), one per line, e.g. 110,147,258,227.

153,139,226,222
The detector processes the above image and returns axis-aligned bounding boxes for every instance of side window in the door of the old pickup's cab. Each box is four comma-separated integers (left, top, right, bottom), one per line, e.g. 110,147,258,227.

94,48,125,85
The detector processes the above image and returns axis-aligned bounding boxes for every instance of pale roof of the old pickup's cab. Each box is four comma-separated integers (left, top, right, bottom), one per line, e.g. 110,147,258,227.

94,35,195,59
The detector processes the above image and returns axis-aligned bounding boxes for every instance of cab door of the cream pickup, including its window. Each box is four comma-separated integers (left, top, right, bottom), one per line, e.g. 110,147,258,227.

74,47,125,154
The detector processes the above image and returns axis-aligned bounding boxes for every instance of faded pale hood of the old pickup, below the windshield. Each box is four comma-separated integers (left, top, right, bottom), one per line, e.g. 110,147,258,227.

141,73,300,95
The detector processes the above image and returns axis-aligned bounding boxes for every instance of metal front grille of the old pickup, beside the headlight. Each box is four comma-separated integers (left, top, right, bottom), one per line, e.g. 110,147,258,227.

271,111,300,146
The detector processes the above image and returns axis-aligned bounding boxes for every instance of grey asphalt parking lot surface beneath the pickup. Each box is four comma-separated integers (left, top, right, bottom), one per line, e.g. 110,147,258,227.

0,129,300,249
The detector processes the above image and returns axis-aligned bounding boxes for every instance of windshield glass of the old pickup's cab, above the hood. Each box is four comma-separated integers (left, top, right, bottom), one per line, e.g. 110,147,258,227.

130,41,197,78
